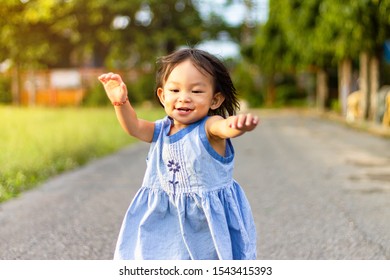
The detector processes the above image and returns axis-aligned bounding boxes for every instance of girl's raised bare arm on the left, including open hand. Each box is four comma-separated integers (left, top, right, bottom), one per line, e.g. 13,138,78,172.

99,73,154,143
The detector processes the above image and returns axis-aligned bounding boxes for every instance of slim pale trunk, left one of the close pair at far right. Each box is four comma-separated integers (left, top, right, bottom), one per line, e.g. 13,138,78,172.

359,52,369,119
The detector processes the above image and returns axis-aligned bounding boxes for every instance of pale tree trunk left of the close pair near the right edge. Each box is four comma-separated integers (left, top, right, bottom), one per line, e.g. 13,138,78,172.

338,58,352,116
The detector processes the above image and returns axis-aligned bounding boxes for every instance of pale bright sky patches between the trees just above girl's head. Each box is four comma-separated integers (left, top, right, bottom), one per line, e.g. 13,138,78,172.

197,0,268,58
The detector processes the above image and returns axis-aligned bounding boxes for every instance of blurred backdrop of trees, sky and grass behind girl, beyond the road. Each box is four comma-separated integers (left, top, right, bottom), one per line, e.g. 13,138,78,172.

0,0,390,201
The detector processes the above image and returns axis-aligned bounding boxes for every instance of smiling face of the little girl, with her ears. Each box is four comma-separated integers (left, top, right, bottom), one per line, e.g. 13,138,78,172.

157,59,225,129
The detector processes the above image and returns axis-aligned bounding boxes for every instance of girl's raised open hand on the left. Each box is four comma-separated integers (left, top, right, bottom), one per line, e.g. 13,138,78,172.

98,72,127,103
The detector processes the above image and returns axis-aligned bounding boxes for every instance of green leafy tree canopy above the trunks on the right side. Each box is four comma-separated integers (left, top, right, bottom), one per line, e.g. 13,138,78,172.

242,0,390,107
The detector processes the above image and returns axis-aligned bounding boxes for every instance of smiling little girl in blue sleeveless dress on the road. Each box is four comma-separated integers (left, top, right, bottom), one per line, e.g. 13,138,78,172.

99,48,259,260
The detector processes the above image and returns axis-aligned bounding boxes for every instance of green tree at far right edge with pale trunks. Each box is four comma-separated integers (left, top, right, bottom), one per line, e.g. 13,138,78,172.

317,0,390,118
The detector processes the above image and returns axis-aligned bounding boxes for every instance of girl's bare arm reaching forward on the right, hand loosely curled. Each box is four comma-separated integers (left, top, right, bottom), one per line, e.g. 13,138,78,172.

206,114,259,140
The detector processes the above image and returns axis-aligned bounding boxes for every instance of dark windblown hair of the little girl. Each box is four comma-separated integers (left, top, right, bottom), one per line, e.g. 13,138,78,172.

156,48,240,118
